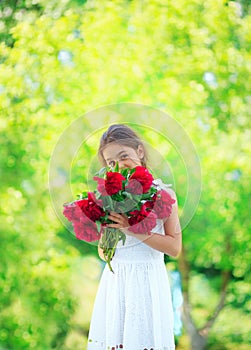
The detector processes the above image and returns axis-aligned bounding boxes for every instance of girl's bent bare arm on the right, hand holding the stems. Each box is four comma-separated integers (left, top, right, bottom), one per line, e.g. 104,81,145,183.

107,189,182,257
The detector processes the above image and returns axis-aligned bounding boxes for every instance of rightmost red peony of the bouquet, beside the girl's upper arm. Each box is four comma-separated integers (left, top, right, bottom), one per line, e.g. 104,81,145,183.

153,190,176,219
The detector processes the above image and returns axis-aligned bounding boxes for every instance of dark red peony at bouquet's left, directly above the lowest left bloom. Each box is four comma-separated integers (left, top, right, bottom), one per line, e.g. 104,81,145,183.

76,192,105,221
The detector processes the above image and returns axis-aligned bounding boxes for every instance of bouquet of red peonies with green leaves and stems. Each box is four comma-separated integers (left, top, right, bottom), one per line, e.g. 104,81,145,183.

63,163,175,272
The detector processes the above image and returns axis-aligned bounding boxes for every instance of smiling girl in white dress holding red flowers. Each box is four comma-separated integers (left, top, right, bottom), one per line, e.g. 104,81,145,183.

87,124,181,350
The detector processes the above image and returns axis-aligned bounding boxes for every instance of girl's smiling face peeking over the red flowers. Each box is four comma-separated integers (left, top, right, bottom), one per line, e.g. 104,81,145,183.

103,143,144,169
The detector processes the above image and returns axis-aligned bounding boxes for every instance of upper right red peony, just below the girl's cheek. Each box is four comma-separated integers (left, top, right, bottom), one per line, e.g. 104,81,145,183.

126,166,153,194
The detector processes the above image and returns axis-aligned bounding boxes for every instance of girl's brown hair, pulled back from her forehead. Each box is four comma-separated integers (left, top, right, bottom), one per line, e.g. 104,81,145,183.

98,124,147,167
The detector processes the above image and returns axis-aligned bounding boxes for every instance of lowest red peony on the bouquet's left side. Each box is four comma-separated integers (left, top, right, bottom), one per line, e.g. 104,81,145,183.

72,213,101,242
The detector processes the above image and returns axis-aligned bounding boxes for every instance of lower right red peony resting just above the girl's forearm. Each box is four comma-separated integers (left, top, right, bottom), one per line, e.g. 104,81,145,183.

128,204,157,234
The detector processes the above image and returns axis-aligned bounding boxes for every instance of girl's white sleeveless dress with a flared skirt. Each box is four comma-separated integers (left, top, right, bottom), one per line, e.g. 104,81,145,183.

87,180,175,350
